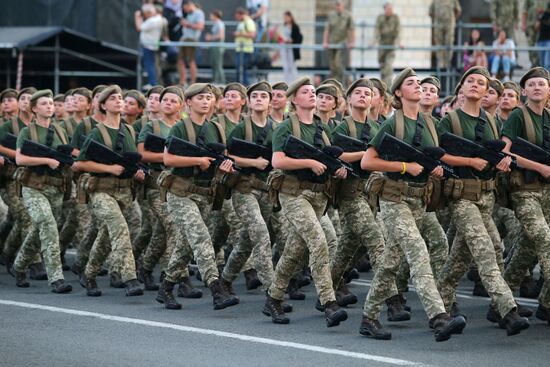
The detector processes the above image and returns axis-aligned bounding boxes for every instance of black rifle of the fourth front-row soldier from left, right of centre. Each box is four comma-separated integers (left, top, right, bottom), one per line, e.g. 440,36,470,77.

283,135,359,181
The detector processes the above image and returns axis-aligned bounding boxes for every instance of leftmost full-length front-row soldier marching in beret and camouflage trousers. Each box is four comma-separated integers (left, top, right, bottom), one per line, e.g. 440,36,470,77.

12,90,72,293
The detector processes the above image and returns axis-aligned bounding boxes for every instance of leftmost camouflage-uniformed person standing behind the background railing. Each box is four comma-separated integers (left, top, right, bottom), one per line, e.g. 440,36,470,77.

323,0,355,82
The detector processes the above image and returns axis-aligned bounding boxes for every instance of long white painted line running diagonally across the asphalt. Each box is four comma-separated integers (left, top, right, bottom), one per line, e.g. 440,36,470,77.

0,299,429,367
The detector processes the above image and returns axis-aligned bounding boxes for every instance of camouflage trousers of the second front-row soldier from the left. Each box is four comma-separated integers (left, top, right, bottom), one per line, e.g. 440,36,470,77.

85,188,136,282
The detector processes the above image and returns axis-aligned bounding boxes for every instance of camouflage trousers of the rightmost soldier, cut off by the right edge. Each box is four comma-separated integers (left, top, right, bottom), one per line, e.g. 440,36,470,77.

504,190,550,307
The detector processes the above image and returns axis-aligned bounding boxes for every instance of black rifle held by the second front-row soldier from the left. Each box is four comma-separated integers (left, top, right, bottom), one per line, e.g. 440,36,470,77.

86,139,149,178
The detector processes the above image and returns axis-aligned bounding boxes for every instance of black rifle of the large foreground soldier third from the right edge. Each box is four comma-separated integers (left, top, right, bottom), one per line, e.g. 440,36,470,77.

377,133,458,178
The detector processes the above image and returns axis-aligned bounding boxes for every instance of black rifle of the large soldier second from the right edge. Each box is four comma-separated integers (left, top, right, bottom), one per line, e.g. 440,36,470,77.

441,133,517,168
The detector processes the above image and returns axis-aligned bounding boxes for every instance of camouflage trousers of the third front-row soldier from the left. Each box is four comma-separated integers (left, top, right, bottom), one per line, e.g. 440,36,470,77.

166,192,219,285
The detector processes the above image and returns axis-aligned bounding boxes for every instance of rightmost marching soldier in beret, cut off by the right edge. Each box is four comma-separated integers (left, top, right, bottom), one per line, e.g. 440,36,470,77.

502,67,550,324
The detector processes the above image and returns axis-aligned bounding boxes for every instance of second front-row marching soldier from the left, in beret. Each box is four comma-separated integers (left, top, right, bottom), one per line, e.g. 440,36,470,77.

76,85,145,297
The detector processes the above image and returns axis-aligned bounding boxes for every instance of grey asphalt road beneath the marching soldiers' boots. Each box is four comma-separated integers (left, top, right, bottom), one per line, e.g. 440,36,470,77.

0,253,550,367
